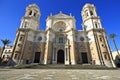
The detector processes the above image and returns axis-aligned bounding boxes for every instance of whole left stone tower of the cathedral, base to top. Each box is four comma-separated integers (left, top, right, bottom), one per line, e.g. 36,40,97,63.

12,4,41,64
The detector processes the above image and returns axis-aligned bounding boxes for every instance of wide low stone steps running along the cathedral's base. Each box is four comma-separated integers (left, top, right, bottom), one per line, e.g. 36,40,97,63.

11,64,115,69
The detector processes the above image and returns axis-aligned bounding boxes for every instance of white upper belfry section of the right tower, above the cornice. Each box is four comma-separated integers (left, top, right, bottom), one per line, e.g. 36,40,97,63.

81,4,102,30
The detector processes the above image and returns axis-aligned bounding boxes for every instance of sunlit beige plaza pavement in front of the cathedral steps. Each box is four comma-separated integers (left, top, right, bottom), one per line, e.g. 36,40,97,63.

0,69,120,80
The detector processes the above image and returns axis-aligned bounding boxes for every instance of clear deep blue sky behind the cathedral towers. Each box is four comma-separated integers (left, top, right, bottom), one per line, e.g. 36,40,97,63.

0,0,120,50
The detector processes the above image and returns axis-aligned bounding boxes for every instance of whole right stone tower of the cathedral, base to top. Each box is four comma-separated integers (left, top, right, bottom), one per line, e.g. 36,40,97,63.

81,4,112,66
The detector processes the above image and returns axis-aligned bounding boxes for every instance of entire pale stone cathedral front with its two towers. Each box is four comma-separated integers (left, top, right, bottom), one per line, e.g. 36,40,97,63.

12,4,113,67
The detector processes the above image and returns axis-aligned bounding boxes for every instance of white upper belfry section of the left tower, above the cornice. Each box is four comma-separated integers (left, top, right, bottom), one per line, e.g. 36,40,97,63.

20,4,41,30
